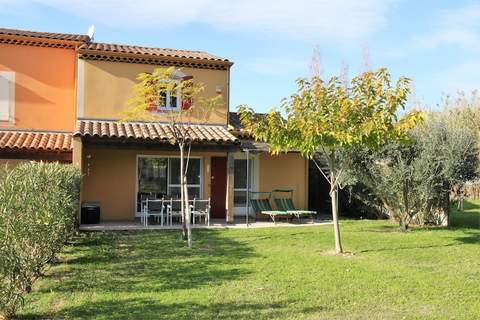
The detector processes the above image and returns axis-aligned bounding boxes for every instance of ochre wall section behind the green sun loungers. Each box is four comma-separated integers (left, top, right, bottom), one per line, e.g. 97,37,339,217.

259,153,308,209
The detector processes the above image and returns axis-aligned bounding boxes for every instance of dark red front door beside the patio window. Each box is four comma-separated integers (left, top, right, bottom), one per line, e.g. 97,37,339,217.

210,157,227,219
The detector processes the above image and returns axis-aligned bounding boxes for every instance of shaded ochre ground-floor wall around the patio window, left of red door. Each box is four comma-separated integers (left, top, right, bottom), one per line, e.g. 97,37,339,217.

82,146,226,221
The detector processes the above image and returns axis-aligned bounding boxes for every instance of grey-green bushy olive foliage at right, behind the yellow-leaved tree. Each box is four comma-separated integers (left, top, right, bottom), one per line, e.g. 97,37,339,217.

349,110,479,230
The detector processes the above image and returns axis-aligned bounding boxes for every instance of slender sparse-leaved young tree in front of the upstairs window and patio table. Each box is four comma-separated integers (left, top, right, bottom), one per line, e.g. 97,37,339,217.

122,67,223,248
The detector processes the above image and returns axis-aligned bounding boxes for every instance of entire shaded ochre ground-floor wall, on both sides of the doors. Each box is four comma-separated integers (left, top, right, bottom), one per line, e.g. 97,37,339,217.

82,146,308,221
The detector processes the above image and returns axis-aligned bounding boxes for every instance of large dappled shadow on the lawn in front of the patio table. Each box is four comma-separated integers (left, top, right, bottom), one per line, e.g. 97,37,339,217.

35,230,255,292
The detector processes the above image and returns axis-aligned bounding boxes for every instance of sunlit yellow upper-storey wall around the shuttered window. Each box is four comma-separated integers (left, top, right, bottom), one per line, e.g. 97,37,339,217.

79,60,229,125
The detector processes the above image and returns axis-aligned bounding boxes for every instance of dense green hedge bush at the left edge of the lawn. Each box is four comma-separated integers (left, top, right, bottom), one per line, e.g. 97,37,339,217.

0,162,81,318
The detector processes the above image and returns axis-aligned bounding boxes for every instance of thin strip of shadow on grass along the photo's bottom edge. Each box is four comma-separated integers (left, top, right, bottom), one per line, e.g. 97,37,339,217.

18,298,327,320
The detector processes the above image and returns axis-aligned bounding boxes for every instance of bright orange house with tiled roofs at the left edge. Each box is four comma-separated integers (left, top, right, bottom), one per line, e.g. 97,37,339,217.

0,28,89,164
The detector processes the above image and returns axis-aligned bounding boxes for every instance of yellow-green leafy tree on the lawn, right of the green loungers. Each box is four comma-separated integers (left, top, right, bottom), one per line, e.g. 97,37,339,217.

239,69,422,253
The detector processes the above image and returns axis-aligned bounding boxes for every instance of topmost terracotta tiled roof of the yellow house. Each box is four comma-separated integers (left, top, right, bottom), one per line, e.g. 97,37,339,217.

79,42,229,62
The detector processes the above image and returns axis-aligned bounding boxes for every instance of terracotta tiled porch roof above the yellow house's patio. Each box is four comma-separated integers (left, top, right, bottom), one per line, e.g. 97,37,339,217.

74,120,237,143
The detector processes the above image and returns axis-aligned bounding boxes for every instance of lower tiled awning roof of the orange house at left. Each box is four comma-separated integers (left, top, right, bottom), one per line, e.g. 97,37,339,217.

0,130,73,151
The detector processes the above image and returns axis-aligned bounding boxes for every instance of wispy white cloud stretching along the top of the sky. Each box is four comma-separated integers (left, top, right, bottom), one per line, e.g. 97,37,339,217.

5,0,397,41
